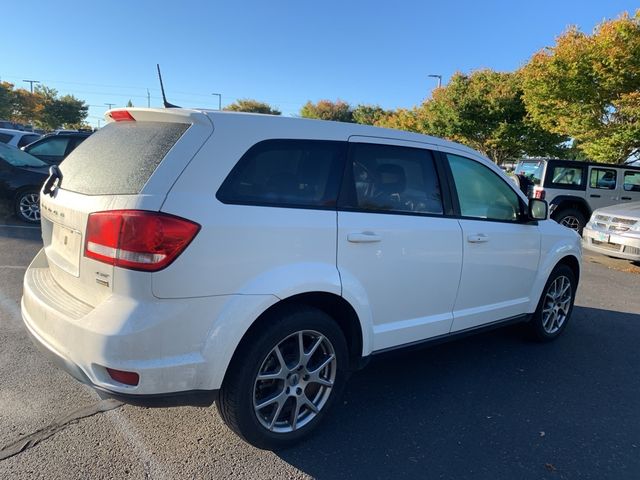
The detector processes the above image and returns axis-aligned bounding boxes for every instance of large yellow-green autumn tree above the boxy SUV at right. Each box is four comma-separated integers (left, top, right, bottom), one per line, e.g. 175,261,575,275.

522,10,640,163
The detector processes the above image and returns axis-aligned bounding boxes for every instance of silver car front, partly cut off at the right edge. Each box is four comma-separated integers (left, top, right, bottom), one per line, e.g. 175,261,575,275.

582,202,640,261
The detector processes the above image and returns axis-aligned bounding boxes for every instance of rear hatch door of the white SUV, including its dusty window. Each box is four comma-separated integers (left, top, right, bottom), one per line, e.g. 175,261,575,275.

40,109,213,306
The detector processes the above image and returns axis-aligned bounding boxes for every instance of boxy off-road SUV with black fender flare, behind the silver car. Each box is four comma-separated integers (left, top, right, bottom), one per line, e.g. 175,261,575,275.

515,158,640,234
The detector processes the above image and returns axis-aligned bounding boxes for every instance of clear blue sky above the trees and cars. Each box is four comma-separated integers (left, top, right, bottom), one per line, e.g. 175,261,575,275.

0,0,640,125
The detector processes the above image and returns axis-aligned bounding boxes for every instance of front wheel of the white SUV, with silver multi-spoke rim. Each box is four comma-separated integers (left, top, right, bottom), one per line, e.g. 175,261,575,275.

528,265,577,342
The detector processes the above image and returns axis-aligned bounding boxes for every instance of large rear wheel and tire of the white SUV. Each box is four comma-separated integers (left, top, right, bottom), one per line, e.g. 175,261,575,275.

216,307,349,450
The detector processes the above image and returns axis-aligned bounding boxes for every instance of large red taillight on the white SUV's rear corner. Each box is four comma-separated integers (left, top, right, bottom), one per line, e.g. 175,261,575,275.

84,210,200,272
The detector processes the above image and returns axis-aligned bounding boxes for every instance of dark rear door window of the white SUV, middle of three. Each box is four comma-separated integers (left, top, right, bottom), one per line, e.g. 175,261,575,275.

342,143,443,215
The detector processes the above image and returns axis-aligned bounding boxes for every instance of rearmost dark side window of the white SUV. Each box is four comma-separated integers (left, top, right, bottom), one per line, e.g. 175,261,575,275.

217,140,346,208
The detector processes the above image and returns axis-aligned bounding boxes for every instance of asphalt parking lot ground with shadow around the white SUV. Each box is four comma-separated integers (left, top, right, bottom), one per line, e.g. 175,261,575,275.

0,219,640,479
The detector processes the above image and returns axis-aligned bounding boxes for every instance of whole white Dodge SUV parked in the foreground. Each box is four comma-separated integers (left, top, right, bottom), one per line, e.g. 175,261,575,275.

22,109,581,448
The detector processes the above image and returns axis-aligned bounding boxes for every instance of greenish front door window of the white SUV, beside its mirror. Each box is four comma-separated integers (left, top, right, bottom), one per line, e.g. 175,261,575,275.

447,153,520,221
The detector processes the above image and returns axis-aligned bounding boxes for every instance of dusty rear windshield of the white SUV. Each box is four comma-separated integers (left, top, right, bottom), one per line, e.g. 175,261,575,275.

60,122,190,195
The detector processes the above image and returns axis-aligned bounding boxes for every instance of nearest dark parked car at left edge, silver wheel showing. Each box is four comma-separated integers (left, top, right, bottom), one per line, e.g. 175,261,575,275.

0,143,49,223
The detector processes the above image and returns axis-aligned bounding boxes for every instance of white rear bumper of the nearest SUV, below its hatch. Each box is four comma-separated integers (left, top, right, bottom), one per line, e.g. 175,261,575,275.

21,251,244,398
